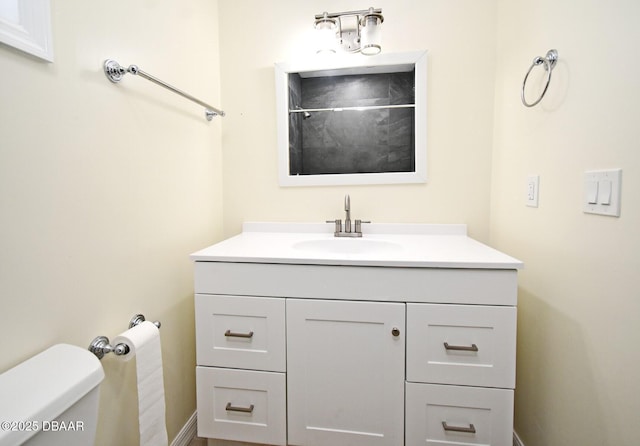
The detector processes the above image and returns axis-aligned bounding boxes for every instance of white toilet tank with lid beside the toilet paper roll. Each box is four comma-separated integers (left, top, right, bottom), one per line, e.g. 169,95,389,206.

0,344,104,446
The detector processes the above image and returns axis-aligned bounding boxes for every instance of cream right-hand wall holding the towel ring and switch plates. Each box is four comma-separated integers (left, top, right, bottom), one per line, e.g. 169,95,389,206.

491,0,640,446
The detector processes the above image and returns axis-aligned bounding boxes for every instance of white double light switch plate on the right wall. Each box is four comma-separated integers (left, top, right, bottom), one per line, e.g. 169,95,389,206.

582,169,622,217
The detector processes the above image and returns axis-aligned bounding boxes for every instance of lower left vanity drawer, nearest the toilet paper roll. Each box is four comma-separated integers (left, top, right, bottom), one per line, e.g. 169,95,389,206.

196,366,287,445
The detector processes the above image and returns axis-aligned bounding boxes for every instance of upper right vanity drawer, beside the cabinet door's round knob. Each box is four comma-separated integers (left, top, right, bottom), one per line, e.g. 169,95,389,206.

407,304,517,389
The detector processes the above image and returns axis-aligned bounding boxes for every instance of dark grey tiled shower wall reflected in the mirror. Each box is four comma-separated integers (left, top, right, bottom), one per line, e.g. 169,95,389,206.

289,72,415,175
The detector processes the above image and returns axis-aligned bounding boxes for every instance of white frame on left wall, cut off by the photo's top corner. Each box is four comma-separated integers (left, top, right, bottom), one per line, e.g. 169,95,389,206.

0,0,53,62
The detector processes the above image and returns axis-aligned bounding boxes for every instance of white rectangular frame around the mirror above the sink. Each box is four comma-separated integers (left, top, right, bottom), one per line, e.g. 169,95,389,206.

275,51,427,186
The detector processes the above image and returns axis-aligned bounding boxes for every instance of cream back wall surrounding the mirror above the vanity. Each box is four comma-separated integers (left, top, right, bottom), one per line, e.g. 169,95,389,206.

220,0,496,240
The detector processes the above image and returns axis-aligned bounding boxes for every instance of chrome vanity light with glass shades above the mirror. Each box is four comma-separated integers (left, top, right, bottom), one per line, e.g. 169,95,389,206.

314,8,384,56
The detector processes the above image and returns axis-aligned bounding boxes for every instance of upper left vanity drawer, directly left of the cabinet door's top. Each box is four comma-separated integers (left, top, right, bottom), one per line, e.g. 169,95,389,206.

195,294,286,372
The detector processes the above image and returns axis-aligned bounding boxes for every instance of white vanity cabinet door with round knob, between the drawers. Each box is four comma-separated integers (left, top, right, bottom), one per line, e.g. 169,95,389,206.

286,299,405,446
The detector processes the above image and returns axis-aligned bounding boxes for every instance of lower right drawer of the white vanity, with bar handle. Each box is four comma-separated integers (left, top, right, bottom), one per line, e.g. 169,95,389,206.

405,383,513,446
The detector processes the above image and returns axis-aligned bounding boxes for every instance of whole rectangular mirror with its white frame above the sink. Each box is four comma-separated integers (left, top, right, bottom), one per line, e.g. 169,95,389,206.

275,51,427,186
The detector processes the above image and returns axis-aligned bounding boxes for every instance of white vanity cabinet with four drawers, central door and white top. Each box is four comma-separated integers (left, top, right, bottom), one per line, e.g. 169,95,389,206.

192,223,521,446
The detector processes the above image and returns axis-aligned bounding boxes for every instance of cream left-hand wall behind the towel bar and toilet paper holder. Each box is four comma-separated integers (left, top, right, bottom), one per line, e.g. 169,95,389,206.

0,0,222,445
